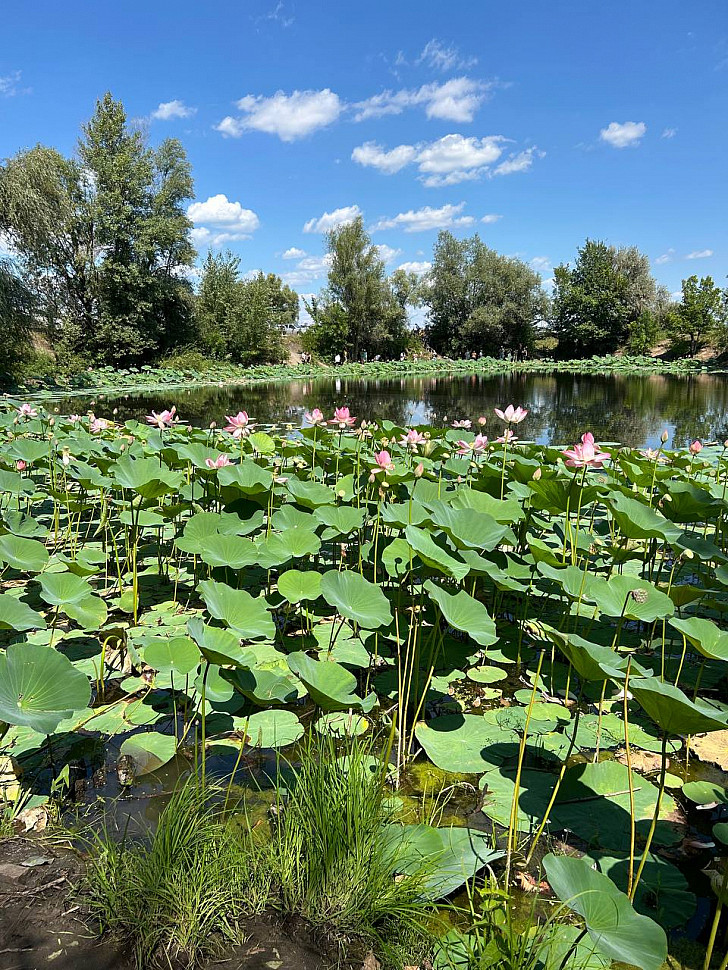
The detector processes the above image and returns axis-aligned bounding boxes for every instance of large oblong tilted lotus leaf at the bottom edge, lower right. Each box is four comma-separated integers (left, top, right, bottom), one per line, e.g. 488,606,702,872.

544,854,667,970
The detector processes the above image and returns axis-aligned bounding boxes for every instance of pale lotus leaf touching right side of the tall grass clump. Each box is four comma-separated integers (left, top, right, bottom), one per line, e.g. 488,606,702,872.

383,824,503,899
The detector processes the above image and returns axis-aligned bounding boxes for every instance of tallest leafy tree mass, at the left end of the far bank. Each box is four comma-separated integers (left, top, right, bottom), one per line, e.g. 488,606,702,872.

0,94,195,363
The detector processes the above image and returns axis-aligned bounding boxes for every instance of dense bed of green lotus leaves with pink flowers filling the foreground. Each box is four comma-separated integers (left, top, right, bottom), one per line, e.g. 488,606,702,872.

0,402,728,970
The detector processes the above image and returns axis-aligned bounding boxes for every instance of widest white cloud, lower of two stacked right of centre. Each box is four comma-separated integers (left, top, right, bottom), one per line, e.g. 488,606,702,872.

351,134,543,188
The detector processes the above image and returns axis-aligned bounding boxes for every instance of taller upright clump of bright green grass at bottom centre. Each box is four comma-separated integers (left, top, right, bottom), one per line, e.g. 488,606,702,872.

271,738,432,953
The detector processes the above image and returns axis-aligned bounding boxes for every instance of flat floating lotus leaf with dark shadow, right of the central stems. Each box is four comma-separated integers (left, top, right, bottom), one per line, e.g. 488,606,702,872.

415,714,503,774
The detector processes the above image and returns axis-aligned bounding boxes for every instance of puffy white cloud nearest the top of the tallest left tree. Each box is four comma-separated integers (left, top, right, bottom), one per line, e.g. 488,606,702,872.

215,88,344,142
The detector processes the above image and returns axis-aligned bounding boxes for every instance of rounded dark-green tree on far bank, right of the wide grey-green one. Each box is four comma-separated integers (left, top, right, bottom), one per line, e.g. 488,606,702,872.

552,239,667,357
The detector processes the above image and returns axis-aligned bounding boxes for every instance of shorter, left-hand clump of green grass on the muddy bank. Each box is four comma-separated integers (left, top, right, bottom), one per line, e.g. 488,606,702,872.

83,778,270,970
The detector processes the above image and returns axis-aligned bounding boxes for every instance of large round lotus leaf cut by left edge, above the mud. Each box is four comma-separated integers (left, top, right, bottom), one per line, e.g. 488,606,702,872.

0,643,91,734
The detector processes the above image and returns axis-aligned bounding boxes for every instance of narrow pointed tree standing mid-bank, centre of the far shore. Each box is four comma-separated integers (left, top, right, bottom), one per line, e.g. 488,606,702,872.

304,217,409,360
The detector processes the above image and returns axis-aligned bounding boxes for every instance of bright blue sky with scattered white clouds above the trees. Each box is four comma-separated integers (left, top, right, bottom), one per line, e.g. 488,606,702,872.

0,0,728,302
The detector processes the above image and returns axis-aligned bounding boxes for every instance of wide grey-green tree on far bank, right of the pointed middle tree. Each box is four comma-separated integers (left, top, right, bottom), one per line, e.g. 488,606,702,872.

424,232,548,357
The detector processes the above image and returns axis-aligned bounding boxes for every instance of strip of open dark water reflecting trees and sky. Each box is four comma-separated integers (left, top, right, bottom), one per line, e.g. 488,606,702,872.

56,374,728,447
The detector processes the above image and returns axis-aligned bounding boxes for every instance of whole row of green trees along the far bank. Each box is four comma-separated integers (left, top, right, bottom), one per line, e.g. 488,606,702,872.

0,94,728,372
